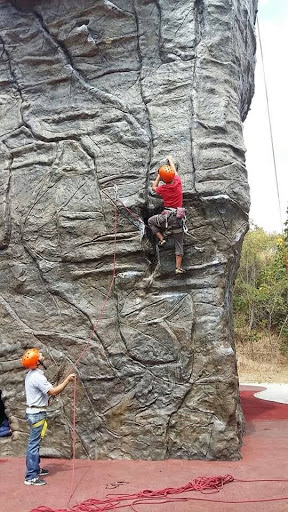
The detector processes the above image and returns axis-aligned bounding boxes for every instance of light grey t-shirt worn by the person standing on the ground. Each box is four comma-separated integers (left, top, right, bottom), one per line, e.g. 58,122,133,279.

25,368,53,414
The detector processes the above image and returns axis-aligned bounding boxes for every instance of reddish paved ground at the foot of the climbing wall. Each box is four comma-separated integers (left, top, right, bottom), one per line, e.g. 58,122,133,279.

0,384,288,512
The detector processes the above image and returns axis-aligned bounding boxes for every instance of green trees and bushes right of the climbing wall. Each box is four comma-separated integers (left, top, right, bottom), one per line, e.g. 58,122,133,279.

234,223,288,353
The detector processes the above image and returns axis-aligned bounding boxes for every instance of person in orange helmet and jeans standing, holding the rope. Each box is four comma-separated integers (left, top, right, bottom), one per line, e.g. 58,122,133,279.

21,348,75,485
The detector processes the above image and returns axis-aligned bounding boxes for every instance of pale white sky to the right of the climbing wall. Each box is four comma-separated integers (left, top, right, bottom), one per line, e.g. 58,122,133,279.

244,0,288,233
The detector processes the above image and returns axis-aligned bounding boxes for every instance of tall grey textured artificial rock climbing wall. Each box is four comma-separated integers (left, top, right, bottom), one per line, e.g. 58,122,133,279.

0,0,257,459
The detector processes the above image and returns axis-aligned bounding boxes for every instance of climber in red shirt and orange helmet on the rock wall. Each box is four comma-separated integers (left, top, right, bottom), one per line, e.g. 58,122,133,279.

148,155,185,274
